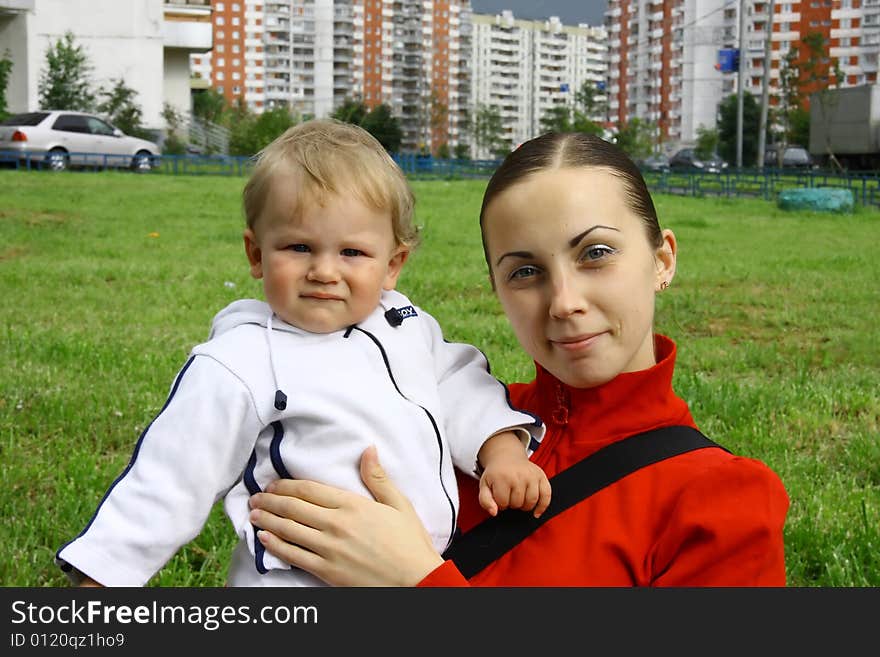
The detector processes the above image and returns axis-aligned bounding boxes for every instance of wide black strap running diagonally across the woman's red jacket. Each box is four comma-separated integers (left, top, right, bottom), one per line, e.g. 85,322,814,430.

443,426,726,578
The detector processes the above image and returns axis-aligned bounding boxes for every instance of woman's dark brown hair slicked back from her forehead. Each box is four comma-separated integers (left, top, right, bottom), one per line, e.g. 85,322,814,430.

480,132,663,271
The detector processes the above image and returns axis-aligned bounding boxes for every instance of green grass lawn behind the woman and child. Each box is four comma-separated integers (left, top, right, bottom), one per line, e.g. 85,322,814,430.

0,171,880,586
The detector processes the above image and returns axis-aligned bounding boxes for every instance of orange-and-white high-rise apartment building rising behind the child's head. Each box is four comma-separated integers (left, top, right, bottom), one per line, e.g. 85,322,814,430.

193,0,470,152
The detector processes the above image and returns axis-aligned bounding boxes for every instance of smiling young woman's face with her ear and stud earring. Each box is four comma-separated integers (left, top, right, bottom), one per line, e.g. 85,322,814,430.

483,167,676,388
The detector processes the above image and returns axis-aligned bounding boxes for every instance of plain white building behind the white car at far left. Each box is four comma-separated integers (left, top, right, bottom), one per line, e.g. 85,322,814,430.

0,0,212,129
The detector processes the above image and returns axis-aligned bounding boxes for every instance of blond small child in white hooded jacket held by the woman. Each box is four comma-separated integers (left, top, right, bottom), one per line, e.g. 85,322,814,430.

56,120,550,586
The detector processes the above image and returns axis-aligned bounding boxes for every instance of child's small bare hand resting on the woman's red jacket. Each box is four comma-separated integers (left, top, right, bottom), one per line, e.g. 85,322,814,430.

480,454,550,518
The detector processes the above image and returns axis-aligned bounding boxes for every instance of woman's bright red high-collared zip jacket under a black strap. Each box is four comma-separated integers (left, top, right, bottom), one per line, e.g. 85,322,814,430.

419,335,789,586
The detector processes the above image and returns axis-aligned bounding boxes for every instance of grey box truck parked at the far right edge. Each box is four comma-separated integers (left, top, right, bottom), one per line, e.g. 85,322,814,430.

809,84,880,170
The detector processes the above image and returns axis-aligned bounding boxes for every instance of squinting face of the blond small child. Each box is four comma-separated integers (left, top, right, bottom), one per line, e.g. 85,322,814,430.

244,183,408,333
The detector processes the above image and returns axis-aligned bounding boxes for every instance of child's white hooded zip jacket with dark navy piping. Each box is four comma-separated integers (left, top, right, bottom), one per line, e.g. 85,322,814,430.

56,292,544,586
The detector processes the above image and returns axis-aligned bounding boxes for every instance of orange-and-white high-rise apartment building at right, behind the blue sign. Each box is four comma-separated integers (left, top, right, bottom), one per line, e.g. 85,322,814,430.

605,0,880,150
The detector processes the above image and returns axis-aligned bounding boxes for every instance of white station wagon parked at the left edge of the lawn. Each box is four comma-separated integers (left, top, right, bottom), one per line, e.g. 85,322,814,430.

0,110,160,171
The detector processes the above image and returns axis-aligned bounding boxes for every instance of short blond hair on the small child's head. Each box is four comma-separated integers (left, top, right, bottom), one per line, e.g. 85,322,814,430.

243,119,419,248
